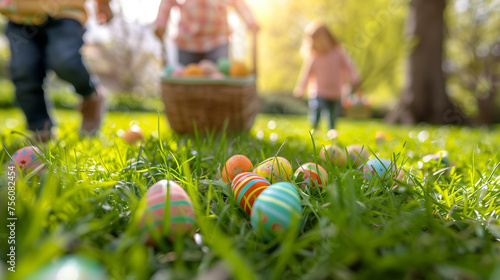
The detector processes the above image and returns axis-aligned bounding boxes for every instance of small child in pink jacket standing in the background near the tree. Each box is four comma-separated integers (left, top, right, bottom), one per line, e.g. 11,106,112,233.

294,23,358,129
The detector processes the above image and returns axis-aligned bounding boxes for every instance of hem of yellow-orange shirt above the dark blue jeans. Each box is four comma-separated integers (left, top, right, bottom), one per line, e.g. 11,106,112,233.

0,0,107,25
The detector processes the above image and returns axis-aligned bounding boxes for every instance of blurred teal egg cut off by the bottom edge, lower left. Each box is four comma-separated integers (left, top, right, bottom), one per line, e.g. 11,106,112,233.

23,255,109,280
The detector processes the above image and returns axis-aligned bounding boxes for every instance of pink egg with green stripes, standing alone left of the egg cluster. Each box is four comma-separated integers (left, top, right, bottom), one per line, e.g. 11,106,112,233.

140,180,195,243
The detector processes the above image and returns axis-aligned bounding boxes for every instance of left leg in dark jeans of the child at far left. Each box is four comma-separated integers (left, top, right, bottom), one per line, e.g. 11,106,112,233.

5,22,52,133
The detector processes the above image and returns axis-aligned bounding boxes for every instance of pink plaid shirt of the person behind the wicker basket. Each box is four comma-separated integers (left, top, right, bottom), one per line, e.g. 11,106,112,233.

155,0,255,52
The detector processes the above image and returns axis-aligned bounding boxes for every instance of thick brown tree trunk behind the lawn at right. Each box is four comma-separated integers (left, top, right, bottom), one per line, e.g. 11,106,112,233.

386,0,466,125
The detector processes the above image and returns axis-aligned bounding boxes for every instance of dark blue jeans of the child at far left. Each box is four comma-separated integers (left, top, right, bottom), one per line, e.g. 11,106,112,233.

5,18,95,131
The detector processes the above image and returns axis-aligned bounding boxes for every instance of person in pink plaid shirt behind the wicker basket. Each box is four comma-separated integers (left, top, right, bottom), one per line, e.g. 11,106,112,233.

155,0,259,65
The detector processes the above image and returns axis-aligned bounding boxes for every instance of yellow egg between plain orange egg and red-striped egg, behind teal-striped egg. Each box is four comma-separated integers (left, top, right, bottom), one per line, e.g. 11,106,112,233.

253,157,293,183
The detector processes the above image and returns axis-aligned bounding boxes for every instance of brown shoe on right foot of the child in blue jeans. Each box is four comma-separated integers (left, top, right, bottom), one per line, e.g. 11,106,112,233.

80,91,106,136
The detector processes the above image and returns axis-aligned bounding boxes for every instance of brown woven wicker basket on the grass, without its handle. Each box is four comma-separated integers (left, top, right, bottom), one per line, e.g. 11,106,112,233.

162,76,260,134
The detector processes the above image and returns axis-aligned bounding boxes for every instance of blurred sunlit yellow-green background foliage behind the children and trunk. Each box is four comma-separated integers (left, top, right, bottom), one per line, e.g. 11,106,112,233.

0,0,500,119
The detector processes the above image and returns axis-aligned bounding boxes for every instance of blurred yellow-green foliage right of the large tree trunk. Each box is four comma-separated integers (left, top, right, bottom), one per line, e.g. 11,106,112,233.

443,0,500,124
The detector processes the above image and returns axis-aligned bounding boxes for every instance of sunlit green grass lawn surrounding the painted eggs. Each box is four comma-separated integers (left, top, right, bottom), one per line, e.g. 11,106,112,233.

0,109,500,279
